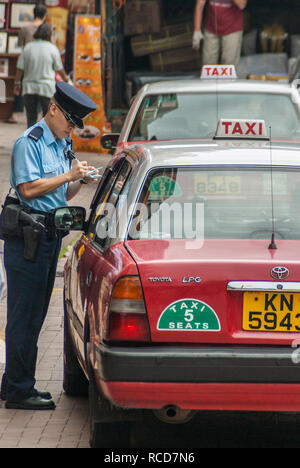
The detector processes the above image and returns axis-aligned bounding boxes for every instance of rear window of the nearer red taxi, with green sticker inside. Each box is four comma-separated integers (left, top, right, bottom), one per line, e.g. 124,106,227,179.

128,167,300,240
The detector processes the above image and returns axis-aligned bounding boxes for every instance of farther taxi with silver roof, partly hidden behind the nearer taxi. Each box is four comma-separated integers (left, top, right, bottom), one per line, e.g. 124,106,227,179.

101,65,300,154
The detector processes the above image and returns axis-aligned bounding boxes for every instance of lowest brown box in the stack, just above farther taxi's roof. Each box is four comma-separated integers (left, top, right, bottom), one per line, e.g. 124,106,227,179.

149,45,201,73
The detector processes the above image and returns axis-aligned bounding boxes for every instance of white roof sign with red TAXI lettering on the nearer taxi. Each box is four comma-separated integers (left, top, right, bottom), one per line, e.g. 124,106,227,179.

215,119,269,140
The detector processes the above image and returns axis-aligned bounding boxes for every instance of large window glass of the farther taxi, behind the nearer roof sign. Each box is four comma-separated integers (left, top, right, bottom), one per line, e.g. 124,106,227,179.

128,92,300,141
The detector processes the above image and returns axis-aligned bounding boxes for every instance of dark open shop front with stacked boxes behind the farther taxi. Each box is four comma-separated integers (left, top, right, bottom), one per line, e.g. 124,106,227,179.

101,0,300,120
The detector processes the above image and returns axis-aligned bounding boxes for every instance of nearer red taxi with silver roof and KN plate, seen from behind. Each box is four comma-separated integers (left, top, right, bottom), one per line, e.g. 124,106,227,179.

55,119,300,447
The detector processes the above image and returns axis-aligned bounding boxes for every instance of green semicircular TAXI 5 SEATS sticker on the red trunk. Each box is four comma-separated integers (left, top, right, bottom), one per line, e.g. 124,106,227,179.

157,299,221,331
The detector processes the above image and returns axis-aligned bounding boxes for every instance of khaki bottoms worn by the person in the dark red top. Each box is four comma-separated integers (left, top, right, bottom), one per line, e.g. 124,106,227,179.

203,30,243,66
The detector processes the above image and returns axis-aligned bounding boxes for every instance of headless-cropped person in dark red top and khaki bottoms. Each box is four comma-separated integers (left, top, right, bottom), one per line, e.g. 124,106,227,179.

192,0,247,66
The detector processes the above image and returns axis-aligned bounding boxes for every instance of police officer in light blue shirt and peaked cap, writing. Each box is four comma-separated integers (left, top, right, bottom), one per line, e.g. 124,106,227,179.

1,82,97,410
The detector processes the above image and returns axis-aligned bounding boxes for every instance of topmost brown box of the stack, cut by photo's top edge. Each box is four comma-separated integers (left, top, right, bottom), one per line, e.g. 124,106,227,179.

124,0,162,36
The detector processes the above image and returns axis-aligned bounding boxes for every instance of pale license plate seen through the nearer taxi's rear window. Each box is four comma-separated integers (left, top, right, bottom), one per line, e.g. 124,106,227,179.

194,174,241,195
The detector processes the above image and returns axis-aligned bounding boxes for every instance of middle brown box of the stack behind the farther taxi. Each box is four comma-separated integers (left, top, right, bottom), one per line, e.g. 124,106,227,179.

130,22,193,57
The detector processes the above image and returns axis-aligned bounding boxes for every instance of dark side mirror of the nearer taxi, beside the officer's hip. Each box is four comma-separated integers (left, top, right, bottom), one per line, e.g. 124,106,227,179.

53,206,86,231
